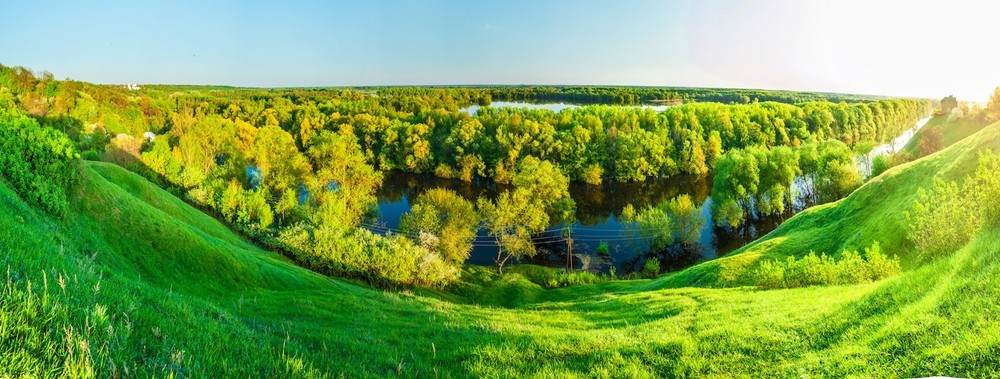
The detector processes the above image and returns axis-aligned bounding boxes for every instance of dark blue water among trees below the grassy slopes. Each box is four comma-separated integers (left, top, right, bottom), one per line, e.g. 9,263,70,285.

364,114,928,274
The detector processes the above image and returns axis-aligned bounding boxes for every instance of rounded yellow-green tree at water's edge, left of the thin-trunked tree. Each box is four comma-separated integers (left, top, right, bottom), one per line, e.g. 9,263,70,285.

400,188,480,264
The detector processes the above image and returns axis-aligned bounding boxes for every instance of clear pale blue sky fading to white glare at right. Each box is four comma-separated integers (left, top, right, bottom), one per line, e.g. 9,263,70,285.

0,0,1000,100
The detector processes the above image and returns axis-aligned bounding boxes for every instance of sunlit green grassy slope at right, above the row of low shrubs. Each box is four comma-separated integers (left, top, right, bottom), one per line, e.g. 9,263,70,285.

649,119,1000,288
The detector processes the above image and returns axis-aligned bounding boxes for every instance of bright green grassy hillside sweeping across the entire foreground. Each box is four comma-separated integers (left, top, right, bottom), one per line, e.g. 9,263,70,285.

0,124,1000,377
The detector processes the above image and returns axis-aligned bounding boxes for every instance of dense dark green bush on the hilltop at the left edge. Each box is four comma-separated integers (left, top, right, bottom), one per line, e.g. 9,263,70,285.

0,109,81,217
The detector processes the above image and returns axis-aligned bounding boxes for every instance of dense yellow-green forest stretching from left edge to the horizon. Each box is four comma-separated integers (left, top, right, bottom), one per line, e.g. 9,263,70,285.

0,66,931,286
